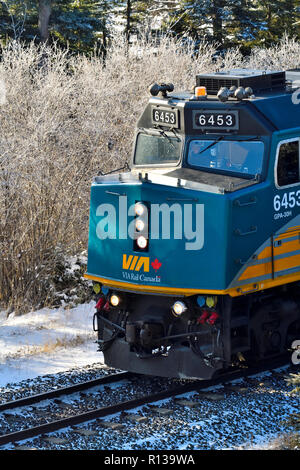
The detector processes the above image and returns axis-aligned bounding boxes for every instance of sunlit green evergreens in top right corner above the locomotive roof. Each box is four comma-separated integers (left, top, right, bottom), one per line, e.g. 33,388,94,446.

172,0,300,51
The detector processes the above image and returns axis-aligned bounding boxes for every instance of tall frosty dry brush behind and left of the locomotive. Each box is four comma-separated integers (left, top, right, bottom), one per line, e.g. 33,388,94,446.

0,34,300,311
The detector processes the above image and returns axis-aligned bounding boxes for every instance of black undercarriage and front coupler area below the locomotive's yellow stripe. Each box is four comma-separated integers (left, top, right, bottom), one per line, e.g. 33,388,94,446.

94,285,300,379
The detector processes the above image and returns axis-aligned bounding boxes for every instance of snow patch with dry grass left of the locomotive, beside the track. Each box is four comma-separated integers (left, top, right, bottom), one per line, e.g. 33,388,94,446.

0,302,103,387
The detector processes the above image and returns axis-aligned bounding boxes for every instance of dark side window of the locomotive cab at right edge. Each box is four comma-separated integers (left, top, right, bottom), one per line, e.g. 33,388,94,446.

277,140,300,186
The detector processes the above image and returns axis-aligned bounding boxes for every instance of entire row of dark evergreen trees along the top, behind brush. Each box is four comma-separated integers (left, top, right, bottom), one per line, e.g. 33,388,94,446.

0,0,300,54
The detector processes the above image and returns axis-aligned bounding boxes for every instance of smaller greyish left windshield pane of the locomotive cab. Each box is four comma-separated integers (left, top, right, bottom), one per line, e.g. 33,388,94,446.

134,132,181,166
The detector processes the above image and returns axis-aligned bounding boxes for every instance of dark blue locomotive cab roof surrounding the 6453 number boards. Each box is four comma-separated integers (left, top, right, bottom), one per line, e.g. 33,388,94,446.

138,69,300,135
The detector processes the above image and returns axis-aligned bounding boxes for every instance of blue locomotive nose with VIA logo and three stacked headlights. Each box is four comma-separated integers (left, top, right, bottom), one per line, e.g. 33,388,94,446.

87,176,229,295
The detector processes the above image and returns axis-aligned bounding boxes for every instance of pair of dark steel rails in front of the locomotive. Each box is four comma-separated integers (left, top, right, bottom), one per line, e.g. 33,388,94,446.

0,360,287,446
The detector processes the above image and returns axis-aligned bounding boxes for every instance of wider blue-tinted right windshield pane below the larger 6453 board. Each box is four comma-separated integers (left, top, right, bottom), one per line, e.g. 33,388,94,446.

188,140,264,176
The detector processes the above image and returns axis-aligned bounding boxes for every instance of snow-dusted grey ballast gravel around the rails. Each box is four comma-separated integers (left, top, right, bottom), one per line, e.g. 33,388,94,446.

0,364,300,451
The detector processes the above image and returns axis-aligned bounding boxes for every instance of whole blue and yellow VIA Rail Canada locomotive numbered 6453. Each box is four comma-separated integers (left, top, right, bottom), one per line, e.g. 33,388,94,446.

86,69,300,379
